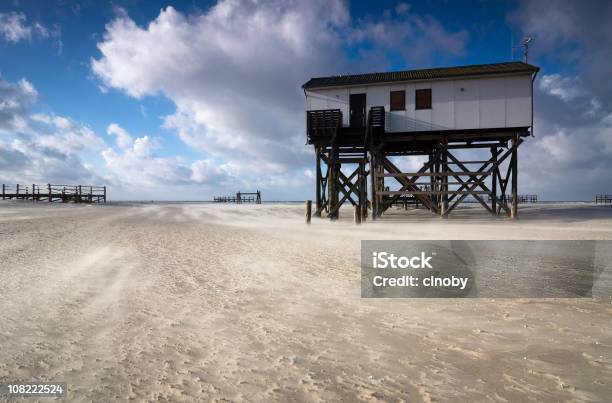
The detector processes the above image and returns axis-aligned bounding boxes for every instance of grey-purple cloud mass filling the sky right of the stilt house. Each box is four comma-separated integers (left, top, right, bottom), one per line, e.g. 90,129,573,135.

510,1,612,200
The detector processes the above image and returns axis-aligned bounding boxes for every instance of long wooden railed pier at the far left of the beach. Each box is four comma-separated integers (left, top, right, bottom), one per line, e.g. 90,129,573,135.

2,183,106,203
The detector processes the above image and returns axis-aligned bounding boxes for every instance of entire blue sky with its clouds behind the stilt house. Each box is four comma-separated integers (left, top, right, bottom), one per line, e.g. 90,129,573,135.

0,0,612,200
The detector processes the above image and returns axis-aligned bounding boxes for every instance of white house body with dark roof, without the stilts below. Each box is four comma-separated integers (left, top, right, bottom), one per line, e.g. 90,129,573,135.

305,62,537,132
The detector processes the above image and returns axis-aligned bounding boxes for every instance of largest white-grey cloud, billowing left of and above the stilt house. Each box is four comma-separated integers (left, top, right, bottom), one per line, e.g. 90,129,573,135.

91,0,467,196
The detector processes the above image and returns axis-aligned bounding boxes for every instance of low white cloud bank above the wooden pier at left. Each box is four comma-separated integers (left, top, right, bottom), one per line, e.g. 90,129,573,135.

0,73,244,198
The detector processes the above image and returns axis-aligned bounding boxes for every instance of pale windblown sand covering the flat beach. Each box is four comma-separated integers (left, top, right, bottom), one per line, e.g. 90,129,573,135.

0,203,612,402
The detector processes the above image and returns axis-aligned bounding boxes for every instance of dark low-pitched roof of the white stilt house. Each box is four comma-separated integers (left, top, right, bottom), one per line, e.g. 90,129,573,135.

302,62,540,89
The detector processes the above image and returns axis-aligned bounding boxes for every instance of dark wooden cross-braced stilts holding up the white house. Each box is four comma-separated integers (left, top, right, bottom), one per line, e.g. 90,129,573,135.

308,113,526,220
